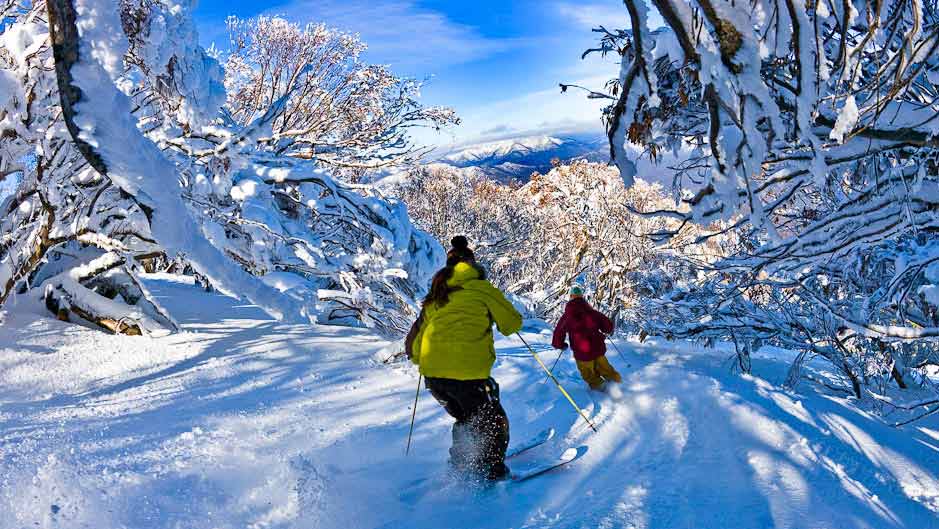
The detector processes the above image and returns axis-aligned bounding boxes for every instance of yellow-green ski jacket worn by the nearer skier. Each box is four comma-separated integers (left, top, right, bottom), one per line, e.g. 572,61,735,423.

409,263,522,380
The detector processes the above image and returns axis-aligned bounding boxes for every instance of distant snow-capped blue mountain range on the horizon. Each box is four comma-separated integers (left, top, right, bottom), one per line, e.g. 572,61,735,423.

436,134,609,182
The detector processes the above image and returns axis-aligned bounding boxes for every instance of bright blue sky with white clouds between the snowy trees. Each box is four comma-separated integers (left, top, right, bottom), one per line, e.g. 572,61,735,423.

196,0,660,145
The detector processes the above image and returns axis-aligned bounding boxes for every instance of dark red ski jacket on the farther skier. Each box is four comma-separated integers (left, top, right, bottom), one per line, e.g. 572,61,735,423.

551,298,613,362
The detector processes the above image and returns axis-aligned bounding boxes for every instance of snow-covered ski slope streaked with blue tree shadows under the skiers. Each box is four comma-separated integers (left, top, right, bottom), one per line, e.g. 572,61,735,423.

0,277,939,529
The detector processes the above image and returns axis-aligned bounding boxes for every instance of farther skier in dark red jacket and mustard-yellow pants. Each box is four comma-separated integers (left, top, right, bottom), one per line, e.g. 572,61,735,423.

551,285,623,389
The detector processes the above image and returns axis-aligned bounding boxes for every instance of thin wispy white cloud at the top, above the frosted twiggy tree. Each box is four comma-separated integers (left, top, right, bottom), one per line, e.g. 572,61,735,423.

267,0,521,74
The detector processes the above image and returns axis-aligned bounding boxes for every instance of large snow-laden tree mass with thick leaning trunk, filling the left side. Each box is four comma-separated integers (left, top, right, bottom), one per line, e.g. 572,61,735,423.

0,0,441,333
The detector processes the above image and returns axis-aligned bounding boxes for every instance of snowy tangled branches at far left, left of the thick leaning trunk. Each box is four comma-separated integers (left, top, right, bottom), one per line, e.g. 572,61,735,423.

0,3,174,333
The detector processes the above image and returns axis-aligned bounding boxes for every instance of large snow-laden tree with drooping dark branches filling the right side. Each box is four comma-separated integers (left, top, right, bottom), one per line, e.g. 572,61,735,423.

591,0,939,395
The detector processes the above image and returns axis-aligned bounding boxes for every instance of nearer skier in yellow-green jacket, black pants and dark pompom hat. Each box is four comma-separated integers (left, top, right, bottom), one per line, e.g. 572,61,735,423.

405,236,522,480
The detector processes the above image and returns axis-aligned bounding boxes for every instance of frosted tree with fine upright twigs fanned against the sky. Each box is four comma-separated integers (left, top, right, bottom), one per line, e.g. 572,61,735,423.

225,16,459,179
